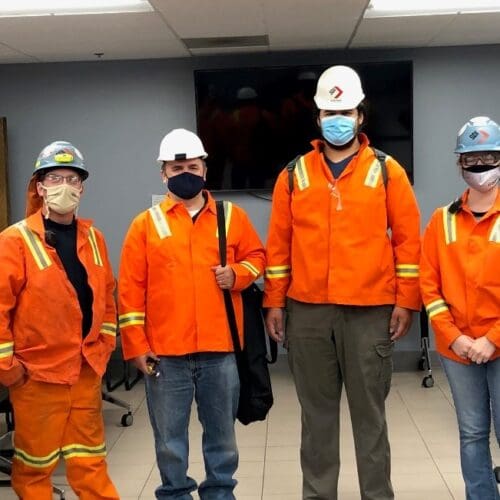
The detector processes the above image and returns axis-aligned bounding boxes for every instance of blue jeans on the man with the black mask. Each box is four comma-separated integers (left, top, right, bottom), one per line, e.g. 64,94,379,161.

146,353,239,500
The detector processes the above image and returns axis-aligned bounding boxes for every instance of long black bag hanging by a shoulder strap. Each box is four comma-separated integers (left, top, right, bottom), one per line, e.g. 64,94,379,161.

216,201,278,425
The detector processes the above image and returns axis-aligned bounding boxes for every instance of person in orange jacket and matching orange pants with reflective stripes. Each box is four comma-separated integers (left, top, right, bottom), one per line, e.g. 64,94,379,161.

0,141,119,500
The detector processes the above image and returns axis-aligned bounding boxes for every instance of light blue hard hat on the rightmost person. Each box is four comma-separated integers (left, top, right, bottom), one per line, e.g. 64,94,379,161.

455,116,500,154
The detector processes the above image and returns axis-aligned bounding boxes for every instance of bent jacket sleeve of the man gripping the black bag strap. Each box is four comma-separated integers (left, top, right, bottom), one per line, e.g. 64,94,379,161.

231,209,266,291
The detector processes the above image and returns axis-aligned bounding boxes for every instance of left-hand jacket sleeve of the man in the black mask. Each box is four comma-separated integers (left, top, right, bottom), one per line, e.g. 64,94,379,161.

118,214,151,359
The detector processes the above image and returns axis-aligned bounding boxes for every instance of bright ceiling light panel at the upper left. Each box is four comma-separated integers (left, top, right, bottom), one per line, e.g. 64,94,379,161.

0,0,153,17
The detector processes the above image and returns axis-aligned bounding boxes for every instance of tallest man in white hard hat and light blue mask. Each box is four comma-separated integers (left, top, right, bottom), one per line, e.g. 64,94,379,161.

264,66,420,500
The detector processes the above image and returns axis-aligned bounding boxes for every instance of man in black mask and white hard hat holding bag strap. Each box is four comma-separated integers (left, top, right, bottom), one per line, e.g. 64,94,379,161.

118,129,265,500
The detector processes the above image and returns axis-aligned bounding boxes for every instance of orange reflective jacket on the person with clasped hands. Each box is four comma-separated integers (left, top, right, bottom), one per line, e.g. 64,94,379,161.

420,191,500,363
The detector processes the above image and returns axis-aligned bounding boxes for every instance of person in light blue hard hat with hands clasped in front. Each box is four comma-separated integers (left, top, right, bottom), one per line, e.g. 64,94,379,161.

420,116,500,500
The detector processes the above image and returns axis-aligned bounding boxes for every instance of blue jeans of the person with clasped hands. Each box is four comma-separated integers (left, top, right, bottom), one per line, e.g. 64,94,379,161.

441,357,500,500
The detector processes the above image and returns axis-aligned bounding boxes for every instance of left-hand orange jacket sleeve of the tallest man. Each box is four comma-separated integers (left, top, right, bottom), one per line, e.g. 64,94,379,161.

264,169,292,307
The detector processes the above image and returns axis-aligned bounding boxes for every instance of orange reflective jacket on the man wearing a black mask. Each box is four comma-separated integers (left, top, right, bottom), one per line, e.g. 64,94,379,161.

118,192,265,359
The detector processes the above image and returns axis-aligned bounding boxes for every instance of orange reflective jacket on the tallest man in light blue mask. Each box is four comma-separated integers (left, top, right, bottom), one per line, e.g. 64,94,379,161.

264,134,420,310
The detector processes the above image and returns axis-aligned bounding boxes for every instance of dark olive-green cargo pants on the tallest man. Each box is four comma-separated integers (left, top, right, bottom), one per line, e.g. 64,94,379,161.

286,299,394,500
